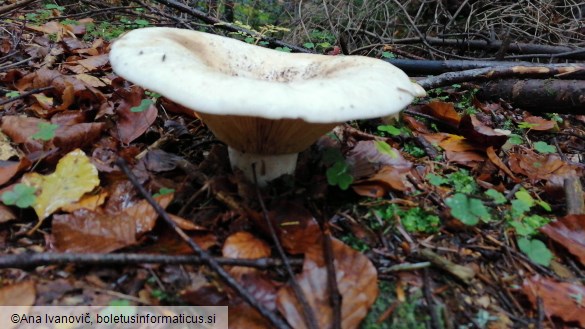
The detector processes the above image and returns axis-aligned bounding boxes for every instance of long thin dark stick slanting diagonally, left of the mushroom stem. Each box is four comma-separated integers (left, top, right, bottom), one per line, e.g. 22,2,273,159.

116,158,290,329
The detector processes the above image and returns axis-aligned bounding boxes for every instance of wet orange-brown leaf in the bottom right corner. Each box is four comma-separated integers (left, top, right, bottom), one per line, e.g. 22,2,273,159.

522,276,585,327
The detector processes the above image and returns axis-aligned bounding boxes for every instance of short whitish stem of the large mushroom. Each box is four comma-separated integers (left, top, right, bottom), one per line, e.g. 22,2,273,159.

228,147,299,186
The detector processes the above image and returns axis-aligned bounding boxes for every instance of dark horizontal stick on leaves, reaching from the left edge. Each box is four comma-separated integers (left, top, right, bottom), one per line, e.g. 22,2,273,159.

0,253,303,269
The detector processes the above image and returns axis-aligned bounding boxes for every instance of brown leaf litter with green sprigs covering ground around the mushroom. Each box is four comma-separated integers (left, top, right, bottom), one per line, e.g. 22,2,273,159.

0,3,585,328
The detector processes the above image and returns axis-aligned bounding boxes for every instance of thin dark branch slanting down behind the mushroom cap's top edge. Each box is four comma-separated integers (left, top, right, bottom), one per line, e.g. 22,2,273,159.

154,0,312,53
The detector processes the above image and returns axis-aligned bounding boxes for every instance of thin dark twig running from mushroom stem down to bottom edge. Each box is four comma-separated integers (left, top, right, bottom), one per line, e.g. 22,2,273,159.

252,164,319,329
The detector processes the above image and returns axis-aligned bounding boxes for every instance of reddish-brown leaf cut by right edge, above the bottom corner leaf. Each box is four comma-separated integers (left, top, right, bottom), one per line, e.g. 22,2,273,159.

540,215,585,265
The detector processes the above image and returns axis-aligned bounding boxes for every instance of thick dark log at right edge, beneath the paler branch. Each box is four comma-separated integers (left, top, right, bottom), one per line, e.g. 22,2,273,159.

477,79,585,114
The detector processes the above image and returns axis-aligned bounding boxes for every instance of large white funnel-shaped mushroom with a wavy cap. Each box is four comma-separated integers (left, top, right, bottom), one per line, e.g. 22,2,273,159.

110,27,425,186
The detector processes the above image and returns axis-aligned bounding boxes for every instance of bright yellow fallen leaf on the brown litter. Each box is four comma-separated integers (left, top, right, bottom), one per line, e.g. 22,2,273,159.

22,149,100,221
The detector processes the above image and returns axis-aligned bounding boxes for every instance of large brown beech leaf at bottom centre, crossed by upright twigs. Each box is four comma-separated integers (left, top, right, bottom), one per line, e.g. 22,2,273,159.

277,239,378,329
